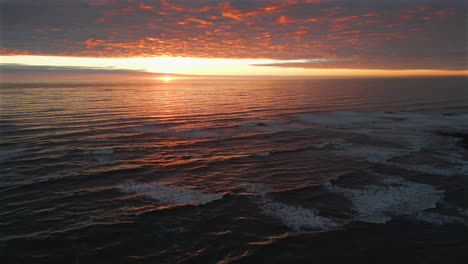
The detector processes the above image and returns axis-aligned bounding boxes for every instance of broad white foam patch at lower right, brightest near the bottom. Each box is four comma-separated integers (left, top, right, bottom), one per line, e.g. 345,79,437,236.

324,177,443,223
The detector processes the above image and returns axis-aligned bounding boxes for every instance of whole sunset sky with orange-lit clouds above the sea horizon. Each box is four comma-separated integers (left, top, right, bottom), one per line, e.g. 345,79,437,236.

0,0,468,76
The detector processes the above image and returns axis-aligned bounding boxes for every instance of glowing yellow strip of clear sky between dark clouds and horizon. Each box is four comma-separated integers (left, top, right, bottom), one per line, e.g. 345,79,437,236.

0,56,468,76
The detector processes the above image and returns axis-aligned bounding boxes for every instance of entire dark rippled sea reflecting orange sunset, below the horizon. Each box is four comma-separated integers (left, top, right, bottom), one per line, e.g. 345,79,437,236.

0,78,468,264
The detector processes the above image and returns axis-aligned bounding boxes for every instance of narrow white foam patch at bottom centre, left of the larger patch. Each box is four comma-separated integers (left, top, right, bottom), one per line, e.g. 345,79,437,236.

258,196,336,230
